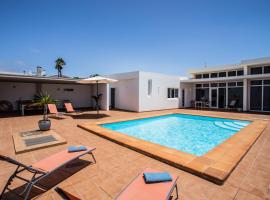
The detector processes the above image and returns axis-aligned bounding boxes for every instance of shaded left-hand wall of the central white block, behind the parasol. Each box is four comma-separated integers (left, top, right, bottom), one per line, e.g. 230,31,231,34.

108,72,139,112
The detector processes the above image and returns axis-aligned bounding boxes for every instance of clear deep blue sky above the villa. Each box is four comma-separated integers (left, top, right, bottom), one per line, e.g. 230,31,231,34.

0,0,270,76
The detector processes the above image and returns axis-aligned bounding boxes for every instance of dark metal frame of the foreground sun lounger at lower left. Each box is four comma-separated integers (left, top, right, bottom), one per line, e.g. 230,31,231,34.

0,148,96,200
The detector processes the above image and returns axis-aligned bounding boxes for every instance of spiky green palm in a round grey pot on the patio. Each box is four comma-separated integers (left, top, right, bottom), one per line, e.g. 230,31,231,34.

34,93,57,131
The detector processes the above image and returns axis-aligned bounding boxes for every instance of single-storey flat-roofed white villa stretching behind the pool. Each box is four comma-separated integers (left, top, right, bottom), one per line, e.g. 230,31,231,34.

0,58,270,112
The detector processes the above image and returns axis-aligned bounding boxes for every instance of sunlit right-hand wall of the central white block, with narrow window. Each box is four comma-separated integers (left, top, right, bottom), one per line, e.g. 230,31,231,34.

139,71,180,112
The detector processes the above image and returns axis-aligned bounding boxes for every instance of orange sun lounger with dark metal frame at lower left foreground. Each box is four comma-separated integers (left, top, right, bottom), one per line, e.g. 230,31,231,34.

0,147,96,200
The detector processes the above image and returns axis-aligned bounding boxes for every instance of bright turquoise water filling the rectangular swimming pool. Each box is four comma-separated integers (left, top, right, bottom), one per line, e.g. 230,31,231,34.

101,114,251,156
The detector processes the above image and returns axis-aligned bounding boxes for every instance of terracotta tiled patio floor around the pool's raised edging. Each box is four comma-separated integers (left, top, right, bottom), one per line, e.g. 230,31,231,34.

0,110,270,200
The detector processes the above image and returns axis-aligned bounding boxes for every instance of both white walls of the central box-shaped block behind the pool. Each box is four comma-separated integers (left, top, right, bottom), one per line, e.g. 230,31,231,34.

109,71,184,112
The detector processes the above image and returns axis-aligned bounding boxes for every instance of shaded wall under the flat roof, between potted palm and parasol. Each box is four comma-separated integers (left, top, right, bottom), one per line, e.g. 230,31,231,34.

41,84,92,108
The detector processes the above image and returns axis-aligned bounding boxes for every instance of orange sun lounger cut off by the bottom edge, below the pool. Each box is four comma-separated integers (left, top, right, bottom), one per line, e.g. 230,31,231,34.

116,169,178,200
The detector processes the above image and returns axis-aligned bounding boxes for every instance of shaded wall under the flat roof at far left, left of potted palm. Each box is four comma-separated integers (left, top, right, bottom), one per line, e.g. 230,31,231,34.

0,82,36,110
